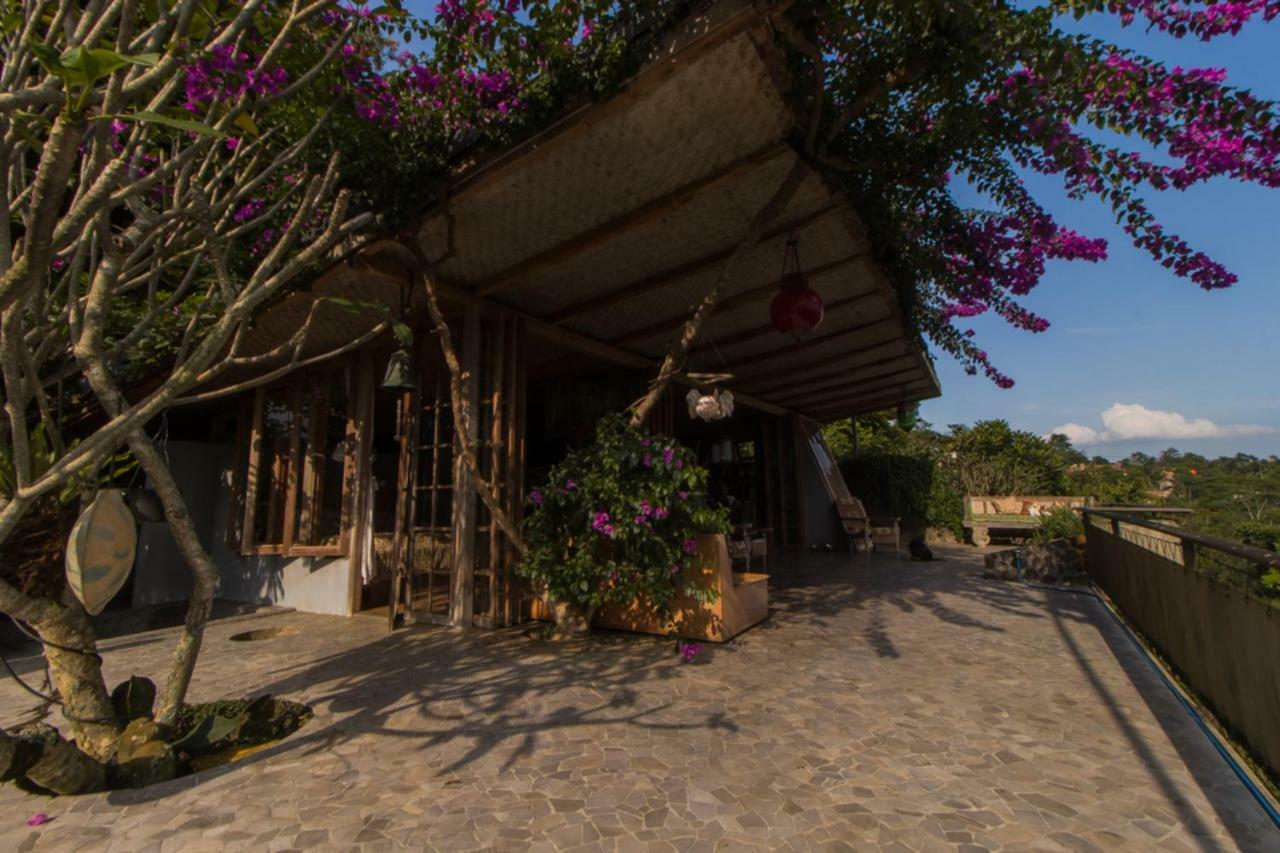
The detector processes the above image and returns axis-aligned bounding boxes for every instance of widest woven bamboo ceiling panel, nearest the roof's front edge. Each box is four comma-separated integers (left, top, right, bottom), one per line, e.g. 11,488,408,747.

422,33,790,284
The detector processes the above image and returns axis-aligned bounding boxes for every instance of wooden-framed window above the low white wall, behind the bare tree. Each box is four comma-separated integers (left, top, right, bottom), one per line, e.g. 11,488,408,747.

239,365,356,556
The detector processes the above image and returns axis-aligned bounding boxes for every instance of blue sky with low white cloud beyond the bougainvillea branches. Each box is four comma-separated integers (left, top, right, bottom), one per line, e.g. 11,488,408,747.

920,18,1280,457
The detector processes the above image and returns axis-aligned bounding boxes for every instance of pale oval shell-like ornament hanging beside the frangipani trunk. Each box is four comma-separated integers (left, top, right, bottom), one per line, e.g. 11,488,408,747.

67,489,138,615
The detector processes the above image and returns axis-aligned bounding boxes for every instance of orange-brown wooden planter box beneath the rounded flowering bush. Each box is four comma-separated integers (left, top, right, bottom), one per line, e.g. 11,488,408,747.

532,533,769,643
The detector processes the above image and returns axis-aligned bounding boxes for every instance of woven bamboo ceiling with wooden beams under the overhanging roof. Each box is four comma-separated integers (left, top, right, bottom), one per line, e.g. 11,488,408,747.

207,0,940,421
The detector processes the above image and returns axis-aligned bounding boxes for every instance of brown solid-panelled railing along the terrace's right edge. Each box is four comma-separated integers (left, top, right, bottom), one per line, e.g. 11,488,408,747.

1083,508,1280,779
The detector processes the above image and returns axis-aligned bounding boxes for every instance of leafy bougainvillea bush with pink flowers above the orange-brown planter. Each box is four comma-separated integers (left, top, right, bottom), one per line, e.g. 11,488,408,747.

521,415,727,612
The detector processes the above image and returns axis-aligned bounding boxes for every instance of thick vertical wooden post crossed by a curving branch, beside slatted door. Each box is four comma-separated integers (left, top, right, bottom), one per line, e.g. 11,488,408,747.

449,305,480,628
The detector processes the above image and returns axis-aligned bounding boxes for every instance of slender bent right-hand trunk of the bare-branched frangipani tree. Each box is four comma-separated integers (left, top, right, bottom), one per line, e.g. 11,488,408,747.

128,430,218,725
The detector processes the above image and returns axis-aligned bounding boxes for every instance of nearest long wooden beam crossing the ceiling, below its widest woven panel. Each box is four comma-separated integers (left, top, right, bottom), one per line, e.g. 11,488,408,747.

472,142,795,296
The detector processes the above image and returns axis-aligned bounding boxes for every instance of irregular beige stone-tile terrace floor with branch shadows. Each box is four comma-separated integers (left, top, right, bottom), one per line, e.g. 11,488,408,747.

0,549,1280,852
